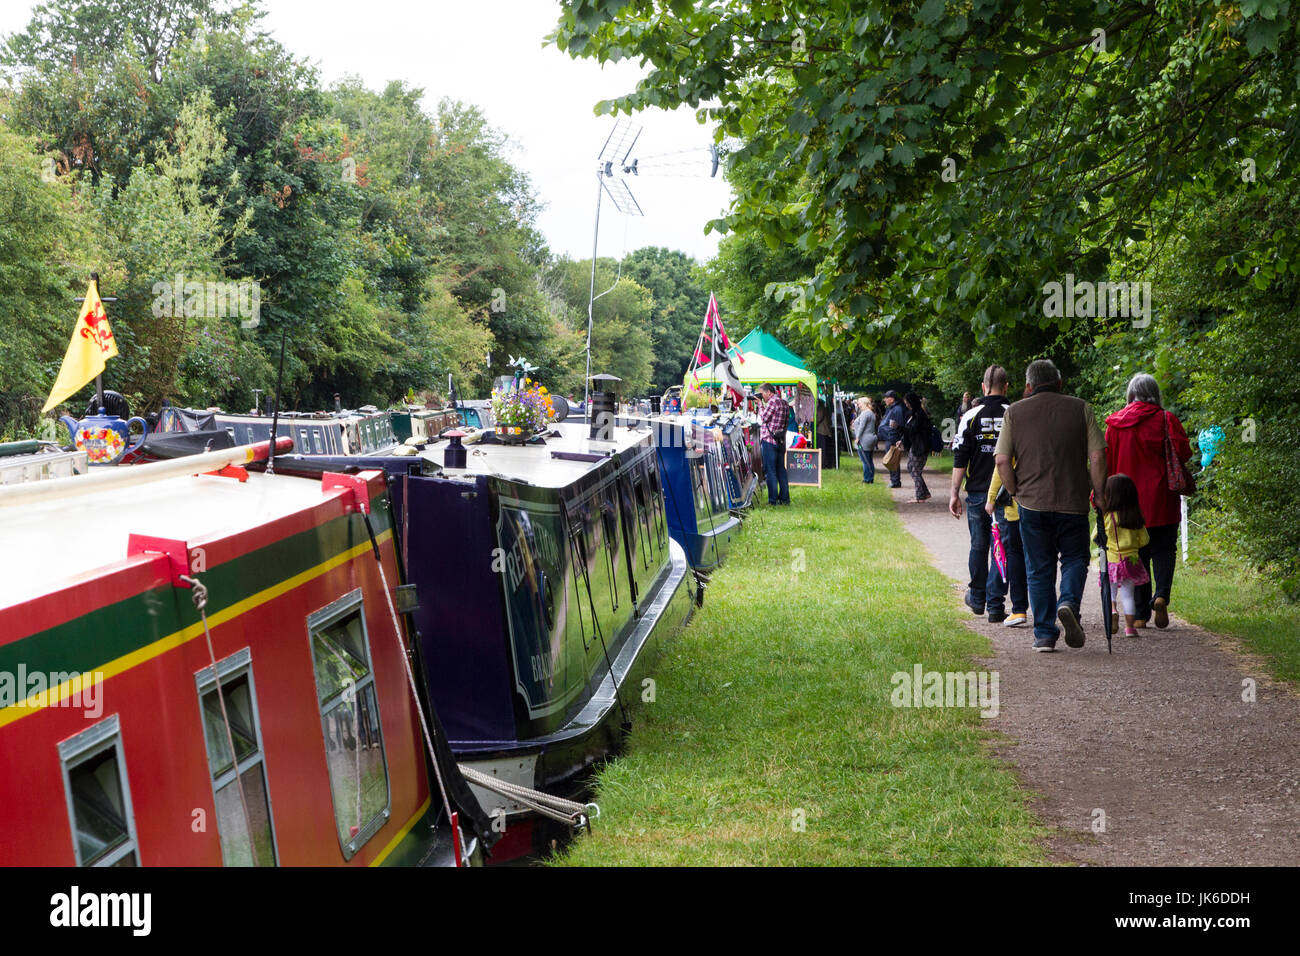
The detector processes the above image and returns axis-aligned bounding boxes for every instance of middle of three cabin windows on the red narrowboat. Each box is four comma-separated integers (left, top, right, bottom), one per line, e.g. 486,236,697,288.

195,648,276,866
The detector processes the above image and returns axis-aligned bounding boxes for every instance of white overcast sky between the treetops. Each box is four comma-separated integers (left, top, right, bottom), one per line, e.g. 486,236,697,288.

0,0,731,260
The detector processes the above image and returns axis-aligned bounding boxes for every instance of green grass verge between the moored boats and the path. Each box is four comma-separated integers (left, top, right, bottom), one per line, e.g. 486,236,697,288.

550,462,1047,866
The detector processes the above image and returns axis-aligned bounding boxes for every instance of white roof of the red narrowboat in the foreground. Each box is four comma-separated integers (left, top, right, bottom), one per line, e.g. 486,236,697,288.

0,464,321,607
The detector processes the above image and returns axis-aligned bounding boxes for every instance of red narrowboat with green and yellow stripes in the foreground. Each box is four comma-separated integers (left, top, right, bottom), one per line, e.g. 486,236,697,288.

0,442,490,866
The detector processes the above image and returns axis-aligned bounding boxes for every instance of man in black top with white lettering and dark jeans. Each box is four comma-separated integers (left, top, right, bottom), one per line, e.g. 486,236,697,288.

948,365,1028,624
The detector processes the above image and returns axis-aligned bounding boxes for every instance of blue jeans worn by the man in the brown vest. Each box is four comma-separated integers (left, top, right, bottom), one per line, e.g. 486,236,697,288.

1019,505,1091,645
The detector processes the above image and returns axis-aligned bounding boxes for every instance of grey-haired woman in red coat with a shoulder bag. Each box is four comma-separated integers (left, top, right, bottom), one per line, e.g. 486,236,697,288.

1106,373,1192,627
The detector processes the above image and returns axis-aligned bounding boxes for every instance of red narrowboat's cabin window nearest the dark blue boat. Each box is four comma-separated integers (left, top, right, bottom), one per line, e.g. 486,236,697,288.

307,588,391,860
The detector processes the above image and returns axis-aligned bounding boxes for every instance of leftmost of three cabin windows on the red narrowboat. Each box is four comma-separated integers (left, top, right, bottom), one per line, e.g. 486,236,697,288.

59,714,139,866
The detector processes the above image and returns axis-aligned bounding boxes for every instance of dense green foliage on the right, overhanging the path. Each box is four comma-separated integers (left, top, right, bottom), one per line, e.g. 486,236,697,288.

553,0,1300,593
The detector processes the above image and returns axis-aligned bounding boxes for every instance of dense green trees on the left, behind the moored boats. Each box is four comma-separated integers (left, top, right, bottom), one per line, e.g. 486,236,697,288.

0,0,707,434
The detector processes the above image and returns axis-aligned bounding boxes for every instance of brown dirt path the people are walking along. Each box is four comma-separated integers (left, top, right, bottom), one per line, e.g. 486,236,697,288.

878,452,1300,866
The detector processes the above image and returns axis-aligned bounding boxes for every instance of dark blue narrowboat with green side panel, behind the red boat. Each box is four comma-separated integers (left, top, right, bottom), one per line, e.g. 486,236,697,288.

276,423,693,858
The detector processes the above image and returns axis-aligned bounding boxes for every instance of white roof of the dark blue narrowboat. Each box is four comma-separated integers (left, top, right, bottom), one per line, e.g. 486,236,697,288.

421,421,651,488
